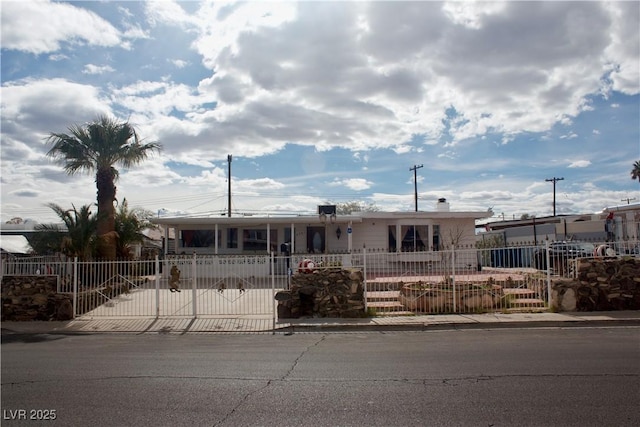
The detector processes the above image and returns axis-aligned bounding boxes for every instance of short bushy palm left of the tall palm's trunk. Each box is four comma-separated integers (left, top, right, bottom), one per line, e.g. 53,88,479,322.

31,203,96,261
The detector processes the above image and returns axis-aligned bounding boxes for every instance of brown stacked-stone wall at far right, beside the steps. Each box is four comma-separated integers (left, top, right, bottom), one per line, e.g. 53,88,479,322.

551,257,640,311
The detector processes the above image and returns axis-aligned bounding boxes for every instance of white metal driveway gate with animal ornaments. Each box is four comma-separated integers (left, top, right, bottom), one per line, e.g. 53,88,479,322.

65,255,287,318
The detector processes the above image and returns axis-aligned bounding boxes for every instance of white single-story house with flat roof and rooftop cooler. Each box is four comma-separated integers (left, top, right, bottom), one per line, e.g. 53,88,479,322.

152,199,492,255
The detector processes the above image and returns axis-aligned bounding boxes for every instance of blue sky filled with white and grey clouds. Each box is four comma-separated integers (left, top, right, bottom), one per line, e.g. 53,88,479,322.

0,0,640,223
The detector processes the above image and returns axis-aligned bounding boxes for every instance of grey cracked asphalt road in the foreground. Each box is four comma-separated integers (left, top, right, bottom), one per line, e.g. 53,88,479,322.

1,327,640,427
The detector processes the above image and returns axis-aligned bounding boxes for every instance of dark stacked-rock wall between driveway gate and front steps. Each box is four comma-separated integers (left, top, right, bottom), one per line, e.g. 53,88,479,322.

276,268,365,319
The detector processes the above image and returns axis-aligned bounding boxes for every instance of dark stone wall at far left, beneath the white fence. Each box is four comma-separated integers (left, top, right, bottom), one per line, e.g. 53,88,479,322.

2,276,73,321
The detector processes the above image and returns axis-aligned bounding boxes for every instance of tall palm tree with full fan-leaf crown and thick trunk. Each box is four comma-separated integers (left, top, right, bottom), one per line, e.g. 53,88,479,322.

47,115,161,259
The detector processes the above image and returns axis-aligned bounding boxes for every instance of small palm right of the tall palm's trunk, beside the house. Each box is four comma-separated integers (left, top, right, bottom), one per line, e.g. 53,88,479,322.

116,198,156,258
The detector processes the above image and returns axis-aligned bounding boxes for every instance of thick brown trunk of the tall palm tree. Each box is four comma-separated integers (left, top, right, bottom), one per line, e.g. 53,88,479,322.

96,167,116,259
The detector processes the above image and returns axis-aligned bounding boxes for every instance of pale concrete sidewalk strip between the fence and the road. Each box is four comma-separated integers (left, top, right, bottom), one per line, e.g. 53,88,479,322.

0,311,640,335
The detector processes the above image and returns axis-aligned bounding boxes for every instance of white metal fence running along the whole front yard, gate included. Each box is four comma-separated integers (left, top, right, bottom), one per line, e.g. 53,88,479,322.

2,242,638,320
